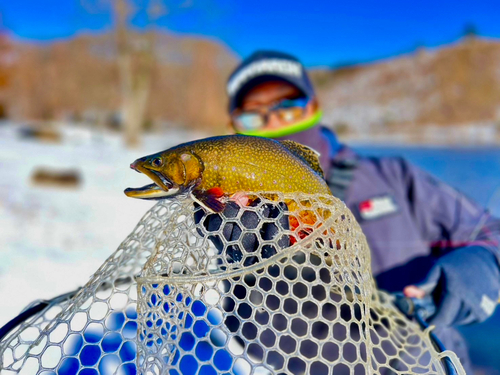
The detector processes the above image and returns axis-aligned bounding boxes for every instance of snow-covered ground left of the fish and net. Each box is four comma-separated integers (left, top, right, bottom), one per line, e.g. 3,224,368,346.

0,125,205,327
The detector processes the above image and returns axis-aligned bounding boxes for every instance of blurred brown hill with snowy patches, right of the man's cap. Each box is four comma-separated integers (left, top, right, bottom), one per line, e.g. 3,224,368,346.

311,37,500,140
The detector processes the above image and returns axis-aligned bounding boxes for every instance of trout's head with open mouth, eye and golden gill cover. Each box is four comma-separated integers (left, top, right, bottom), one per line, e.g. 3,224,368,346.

125,150,203,199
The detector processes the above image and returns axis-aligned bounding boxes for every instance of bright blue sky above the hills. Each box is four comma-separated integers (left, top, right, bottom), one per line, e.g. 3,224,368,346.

0,0,500,66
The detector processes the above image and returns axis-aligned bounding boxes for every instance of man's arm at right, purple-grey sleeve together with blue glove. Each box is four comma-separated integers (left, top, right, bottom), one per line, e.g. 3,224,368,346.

393,159,500,325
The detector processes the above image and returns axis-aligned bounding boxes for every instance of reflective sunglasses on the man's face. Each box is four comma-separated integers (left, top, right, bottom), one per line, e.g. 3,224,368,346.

231,98,310,132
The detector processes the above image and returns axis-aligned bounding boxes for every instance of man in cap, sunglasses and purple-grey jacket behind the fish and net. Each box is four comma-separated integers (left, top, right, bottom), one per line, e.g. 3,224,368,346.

209,51,500,373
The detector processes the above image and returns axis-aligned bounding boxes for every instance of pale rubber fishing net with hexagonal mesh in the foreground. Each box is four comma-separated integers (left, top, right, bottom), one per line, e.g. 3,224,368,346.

0,193,461,375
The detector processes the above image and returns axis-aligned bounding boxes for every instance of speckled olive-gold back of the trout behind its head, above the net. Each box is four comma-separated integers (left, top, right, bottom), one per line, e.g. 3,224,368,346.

172,135,331,195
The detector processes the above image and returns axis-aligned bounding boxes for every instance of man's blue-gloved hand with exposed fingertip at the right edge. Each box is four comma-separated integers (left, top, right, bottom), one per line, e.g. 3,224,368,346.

403,246,500,326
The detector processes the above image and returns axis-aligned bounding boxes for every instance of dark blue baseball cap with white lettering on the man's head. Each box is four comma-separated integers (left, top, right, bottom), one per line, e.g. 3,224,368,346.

226,51,315,112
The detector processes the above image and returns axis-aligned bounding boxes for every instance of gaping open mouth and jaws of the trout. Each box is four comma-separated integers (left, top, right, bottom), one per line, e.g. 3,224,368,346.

125,164,179,199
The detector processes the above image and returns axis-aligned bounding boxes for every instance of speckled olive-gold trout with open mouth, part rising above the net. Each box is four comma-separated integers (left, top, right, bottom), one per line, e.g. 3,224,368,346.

125,134,331,213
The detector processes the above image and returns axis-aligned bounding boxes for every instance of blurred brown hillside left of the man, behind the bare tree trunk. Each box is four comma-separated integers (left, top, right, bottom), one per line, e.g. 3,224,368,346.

0,33,238,132
